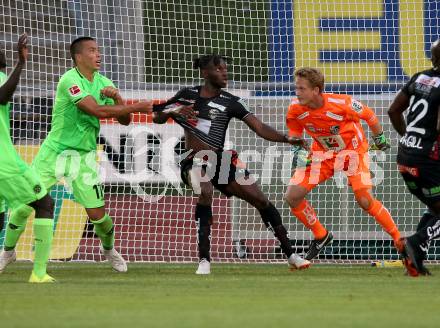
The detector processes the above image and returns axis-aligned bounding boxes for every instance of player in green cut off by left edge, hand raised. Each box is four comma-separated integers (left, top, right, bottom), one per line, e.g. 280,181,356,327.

0,34,55,283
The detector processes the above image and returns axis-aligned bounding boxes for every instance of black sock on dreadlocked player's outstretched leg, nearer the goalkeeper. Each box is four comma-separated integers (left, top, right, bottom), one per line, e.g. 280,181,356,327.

260,203,293,258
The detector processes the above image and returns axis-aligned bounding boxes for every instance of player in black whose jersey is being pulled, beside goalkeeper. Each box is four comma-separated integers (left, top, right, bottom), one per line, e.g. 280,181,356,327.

153,55,310,274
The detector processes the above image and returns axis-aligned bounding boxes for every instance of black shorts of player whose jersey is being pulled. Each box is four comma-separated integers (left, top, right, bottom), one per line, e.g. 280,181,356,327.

180,150,250,197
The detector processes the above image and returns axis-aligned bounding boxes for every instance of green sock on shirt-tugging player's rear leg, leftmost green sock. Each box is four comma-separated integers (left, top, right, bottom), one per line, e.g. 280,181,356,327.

4,205,33,251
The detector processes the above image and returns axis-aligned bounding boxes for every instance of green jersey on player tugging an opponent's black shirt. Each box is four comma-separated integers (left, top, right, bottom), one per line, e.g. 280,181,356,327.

43,68,114,153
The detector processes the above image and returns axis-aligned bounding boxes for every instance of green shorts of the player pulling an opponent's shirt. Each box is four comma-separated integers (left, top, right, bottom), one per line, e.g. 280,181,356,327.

32,145,105,208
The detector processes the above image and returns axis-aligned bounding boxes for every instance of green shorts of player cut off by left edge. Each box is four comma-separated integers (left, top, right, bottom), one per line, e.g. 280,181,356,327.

0,167,47,209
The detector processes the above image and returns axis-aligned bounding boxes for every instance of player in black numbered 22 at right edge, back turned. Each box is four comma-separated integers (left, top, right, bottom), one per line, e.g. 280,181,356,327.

388,39,440,276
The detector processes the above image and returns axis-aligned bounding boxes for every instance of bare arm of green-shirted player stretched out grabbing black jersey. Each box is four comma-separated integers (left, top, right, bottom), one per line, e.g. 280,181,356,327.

77,96,153,119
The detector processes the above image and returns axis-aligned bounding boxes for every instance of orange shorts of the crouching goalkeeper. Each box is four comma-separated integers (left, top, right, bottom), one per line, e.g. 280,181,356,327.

289,151,373,191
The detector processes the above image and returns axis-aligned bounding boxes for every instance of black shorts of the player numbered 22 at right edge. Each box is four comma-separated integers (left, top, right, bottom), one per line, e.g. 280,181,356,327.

398,164,440,206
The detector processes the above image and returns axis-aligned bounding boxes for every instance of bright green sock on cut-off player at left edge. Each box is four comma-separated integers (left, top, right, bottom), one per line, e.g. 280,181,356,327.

34,218,54,278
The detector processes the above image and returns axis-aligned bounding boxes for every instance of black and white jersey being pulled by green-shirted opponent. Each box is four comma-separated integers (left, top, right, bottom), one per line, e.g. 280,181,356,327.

153,86,250,150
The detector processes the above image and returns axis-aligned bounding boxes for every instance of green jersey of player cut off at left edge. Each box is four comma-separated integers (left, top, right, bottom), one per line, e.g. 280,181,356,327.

0,72,27,180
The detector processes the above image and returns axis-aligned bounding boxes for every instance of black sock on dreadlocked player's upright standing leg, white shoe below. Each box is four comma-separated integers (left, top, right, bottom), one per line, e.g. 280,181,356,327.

196,204,212,261
